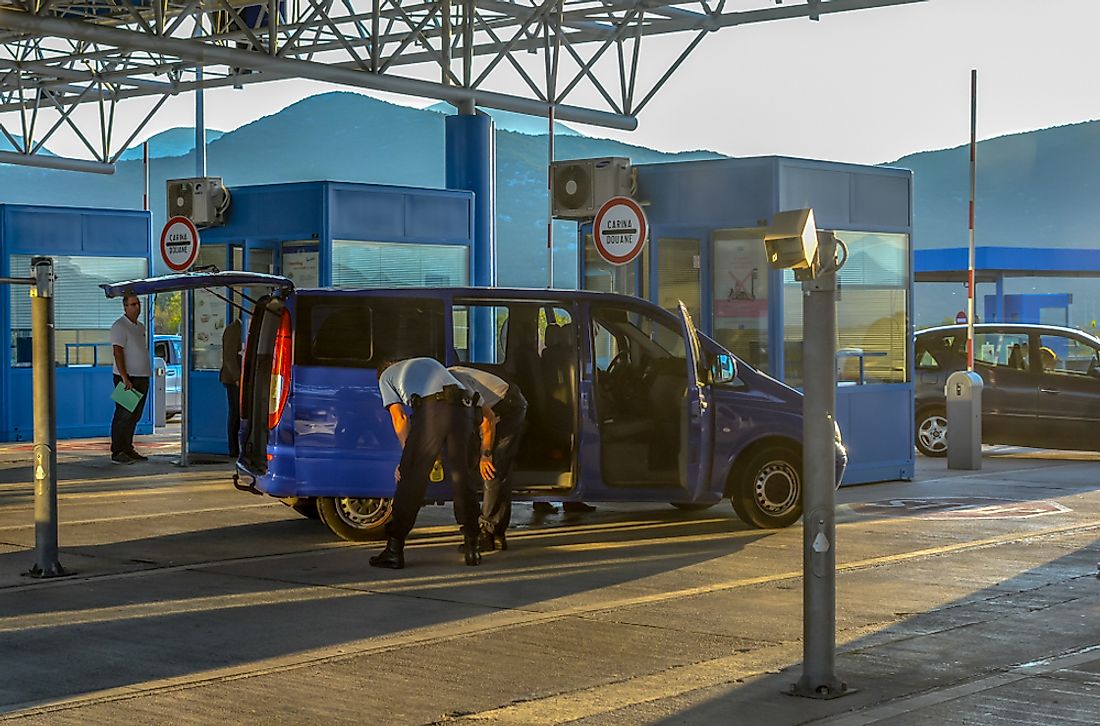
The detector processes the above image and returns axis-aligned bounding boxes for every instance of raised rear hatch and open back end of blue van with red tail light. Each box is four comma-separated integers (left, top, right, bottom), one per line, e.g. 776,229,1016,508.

100,271,294,475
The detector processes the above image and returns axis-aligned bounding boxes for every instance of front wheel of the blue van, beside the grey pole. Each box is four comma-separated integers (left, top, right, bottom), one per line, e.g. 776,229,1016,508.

729,447,802,529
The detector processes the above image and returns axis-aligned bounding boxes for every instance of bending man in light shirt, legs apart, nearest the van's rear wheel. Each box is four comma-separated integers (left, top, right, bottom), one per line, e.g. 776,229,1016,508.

371,358,481,570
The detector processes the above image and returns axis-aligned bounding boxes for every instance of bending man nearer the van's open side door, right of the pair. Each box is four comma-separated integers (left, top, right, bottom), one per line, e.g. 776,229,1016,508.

448,365,527,552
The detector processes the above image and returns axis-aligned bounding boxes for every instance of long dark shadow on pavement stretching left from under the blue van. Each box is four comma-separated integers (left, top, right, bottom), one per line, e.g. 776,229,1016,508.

0,501,768,711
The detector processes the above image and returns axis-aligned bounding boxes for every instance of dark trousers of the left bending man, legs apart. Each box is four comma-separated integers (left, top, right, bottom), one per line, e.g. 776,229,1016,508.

386,399,477,541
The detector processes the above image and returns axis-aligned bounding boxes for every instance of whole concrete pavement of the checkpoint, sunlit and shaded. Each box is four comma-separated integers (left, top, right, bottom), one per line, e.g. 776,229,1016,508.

0,436,1100,725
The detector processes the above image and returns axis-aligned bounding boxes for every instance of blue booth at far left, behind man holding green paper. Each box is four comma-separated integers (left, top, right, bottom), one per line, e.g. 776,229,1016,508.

0,205,153,441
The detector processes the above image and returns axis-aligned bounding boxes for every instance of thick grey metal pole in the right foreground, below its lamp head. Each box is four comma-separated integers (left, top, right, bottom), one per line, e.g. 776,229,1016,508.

792,232,849,699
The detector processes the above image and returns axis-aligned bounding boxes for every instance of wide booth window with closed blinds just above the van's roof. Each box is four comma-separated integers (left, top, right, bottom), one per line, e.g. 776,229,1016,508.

332,240,470,287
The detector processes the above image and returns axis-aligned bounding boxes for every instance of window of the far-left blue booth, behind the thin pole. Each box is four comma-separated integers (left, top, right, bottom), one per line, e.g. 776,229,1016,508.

8,254,149,366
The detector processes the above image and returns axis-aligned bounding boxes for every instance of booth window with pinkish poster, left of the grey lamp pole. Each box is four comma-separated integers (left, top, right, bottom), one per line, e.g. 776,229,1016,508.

712,228,769,371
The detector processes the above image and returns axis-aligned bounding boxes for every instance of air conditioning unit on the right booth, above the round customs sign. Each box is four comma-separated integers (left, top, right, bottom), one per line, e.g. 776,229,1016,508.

551,156,633,219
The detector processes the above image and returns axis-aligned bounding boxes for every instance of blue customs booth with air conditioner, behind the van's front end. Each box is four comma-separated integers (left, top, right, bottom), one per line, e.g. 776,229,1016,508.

578,156,914,484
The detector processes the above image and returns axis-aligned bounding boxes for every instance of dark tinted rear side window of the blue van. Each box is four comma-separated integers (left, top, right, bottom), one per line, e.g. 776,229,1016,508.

295,295,443,369
